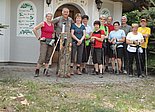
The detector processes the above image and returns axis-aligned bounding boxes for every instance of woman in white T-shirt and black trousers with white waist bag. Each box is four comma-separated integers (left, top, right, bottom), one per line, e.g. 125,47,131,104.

126,24,144,77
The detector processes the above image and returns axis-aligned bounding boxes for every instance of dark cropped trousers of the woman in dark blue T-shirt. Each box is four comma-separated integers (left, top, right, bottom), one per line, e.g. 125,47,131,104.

71,42,84,64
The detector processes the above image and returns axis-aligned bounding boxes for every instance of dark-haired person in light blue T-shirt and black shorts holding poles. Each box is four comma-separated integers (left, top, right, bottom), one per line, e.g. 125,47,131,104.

109,21,125,73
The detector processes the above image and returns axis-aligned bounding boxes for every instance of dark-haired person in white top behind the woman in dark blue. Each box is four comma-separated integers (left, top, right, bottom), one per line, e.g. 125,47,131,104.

82,15,92,73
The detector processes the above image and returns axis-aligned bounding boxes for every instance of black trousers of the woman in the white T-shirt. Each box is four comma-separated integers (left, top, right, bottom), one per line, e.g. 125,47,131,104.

128,52,142,76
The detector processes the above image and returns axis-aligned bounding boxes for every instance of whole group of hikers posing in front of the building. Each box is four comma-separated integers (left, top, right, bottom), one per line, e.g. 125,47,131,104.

33,8,151,78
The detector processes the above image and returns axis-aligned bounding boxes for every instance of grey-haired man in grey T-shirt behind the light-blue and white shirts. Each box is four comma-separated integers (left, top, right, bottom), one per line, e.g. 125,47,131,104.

121,16,132,74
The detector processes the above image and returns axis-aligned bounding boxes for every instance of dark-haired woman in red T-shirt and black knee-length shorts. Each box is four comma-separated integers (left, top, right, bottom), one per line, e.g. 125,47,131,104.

91,21,105,78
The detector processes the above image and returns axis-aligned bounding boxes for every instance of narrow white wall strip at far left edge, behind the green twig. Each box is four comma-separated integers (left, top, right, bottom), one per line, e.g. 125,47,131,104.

0,0,10,62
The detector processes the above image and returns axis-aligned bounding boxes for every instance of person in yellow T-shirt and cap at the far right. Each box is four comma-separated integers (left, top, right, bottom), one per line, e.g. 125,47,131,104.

138,18,151,72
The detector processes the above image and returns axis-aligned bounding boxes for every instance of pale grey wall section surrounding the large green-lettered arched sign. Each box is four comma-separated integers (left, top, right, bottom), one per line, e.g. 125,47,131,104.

10,0,44,63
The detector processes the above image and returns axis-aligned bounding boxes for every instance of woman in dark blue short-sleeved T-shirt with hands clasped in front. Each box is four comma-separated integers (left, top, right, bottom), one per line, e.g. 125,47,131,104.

70,13,86,75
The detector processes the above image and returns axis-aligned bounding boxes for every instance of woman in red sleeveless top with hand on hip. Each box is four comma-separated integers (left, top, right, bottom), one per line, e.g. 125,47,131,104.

33,13,54,77
